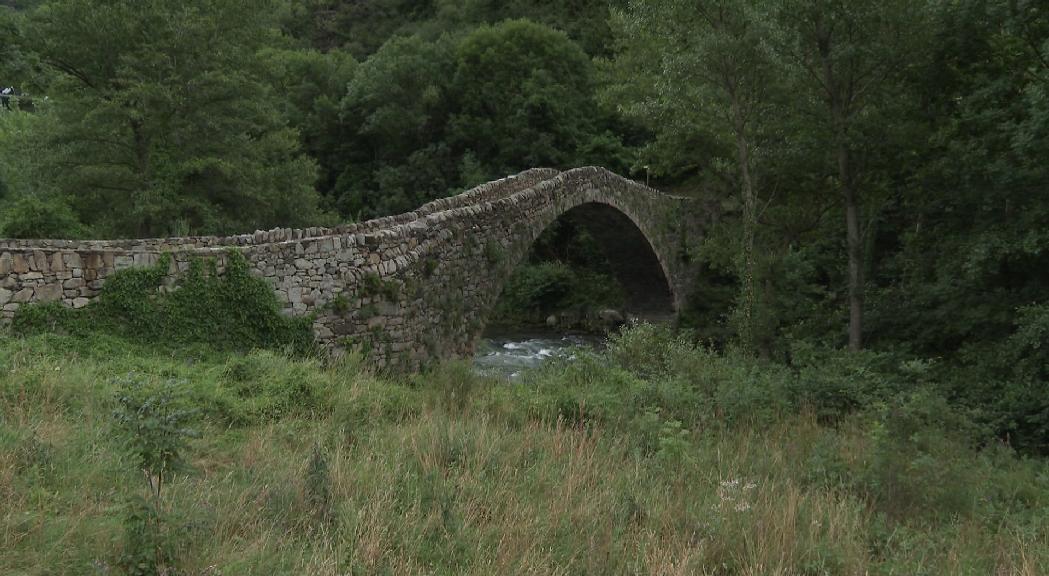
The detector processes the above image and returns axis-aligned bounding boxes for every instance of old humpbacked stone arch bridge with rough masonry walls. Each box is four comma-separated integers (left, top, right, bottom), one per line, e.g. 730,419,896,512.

0,168,703,366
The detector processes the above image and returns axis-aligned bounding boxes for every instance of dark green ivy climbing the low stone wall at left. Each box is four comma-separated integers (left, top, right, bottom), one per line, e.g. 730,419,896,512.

13,251,314,354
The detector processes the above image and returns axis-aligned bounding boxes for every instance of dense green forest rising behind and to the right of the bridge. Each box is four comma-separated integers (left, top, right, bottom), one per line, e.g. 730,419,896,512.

0,0,1049,451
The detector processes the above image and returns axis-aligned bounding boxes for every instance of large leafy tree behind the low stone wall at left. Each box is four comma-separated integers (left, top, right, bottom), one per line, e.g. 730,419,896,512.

25,0,320,236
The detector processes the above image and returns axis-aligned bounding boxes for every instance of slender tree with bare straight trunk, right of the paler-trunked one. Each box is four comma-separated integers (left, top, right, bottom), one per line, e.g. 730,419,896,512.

774,0,927,350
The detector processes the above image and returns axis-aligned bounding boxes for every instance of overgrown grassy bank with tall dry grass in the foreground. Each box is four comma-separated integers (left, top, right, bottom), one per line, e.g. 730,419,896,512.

0,328,1049,575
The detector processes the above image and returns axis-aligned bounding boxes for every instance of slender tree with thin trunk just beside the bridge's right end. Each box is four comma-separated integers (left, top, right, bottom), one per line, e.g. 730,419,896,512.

608,0,776,349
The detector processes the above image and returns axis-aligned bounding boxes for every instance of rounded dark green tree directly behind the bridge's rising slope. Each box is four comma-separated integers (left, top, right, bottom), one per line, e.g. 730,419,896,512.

335,21,625,217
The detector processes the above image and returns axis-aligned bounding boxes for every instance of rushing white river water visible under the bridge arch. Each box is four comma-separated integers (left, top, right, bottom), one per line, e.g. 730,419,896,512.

473,334,603,379
